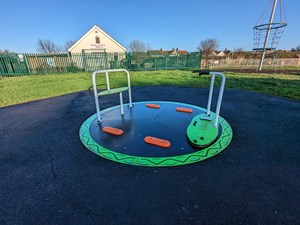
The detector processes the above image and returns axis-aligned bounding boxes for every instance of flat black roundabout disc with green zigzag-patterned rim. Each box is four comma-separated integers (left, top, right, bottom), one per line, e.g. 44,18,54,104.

79,101,232,167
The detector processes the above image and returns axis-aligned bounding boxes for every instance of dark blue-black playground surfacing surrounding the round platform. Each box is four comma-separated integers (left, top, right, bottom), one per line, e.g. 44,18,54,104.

0,87,300,225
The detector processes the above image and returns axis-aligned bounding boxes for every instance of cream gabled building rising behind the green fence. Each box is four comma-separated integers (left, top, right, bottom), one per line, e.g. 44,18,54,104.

68,25,126,53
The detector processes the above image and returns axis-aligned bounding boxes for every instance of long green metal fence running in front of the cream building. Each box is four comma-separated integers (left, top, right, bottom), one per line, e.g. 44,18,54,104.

0,52,201,76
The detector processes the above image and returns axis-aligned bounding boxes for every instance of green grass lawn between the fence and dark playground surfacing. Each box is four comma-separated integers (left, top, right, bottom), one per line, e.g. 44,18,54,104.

0,70,300,107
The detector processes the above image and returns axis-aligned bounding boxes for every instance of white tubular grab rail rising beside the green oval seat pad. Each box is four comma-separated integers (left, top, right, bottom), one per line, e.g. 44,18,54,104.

206,72,226,127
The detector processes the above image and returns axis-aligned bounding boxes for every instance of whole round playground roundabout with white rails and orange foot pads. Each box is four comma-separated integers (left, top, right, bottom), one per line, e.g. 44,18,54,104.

79,69,233,167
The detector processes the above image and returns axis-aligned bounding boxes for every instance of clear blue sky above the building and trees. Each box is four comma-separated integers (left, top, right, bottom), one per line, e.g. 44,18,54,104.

0,0,300,52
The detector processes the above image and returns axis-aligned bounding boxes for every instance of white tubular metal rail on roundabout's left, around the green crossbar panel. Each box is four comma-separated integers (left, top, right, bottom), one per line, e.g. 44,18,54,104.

92,69,132,123
